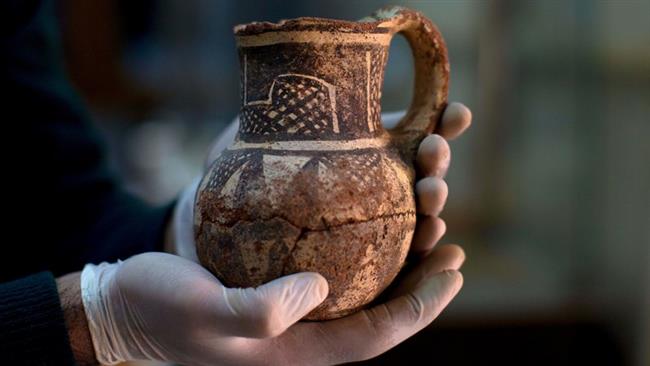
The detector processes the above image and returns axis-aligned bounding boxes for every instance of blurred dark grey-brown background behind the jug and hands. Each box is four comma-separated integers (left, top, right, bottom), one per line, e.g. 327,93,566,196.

53,0,650,365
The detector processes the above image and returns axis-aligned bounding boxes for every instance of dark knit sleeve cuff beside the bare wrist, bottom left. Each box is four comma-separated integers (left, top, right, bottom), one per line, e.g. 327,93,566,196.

0,272,75,365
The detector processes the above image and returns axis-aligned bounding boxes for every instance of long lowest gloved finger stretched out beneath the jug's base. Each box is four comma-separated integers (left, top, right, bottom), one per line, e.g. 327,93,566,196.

271,270,463,365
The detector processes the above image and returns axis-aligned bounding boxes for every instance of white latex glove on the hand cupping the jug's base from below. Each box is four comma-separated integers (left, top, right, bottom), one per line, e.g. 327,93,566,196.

81,250,464,365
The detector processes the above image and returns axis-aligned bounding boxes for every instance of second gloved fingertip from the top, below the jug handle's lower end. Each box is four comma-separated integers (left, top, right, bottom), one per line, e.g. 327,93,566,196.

415,135,451,178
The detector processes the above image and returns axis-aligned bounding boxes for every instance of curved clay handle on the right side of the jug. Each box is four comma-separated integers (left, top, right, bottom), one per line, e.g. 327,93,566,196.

371,6,449,158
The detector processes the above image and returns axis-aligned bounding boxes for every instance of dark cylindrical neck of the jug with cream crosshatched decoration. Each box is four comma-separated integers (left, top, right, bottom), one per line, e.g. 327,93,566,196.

235,18,391,142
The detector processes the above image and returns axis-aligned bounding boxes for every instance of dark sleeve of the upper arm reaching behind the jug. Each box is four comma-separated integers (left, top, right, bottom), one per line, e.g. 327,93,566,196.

0,0,171,282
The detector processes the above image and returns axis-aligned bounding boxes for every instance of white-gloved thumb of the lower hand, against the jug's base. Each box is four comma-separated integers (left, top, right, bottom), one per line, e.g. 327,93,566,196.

217,272,329,338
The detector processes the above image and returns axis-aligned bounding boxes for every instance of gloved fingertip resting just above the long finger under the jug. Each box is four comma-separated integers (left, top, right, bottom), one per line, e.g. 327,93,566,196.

390,244,465,298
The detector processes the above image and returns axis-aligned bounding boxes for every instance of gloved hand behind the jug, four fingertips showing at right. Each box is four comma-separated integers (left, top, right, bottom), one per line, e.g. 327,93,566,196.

167,103,472,262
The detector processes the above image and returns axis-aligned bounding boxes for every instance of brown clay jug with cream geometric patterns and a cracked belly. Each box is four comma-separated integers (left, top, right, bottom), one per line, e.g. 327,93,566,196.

195,8,449,320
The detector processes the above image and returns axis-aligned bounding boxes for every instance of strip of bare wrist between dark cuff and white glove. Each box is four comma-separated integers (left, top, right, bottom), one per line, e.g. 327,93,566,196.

56,272,98,366
